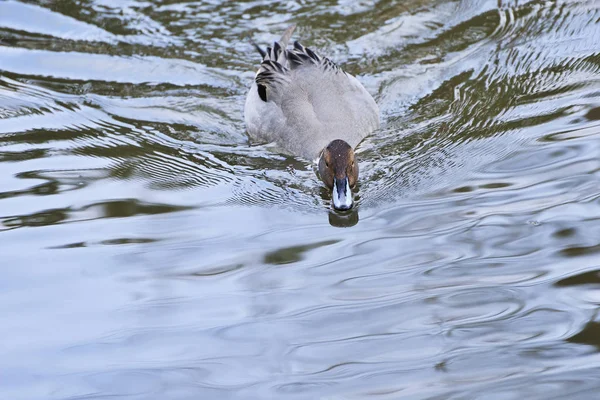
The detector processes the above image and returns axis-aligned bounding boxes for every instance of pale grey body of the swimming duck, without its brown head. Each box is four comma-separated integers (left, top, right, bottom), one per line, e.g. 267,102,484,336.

244,29,379,159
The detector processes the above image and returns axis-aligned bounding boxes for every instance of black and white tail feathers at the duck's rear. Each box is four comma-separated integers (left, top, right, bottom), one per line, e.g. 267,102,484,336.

252,25,345,102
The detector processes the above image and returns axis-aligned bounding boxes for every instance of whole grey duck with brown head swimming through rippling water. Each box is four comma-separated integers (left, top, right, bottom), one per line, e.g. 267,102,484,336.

244,25,379,211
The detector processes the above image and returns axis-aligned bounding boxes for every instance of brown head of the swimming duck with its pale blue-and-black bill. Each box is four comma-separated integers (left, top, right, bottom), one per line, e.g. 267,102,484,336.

319,139,358,210
